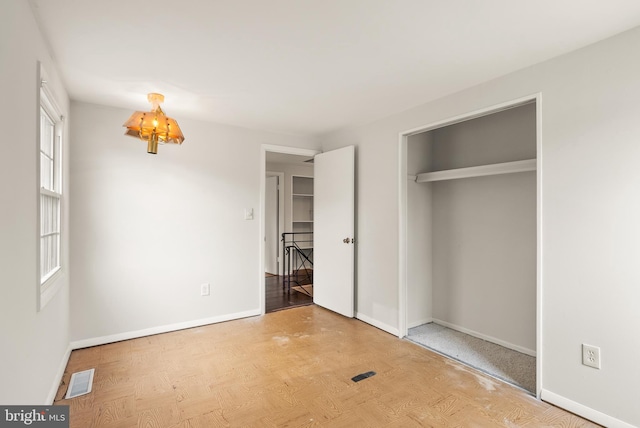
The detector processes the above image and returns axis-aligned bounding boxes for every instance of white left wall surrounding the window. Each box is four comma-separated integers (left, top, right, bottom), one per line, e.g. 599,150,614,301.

0,0,69,404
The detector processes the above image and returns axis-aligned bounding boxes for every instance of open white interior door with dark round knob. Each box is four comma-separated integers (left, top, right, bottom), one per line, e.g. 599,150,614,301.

313,146,355,318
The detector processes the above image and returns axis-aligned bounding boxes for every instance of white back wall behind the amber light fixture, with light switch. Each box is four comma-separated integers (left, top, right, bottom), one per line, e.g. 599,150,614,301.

71,102,313,344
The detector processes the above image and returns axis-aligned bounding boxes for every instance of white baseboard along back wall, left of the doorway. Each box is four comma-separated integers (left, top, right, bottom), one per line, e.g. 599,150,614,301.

71,309,262,350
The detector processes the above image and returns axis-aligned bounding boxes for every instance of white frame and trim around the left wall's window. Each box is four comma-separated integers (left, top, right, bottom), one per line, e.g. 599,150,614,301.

36,70,64,310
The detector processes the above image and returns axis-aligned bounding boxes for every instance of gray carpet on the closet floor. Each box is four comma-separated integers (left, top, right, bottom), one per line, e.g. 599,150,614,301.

407,323,536,395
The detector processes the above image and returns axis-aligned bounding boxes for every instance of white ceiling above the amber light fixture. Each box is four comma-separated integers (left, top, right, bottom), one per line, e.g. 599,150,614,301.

30,0,640,136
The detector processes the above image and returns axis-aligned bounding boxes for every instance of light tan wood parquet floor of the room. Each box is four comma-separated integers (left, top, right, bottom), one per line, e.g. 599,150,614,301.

56,305,597,428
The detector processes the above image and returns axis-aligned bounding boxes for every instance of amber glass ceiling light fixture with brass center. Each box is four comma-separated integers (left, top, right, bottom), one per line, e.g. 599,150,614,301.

122,93,184,155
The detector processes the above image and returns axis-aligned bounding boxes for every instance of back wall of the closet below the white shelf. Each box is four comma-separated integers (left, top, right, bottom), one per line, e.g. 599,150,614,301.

430,172,536,354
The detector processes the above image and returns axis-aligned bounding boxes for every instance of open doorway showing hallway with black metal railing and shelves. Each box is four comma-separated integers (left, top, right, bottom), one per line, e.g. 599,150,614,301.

261,146,318,313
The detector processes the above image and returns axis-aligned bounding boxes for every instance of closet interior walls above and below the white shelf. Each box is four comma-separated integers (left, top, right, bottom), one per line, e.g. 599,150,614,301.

408,104,537,353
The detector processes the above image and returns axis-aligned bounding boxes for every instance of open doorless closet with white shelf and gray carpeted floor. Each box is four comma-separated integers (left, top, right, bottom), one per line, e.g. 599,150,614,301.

400,97,541,395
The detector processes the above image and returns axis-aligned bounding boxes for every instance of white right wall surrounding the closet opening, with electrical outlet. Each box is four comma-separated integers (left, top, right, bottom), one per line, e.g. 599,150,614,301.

323,25,640,426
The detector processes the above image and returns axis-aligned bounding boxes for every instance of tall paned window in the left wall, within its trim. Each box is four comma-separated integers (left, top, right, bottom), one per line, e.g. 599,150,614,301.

39,82,62,298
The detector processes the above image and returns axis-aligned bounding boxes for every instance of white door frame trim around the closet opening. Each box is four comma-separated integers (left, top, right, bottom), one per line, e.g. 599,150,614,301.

398,93,544,399
